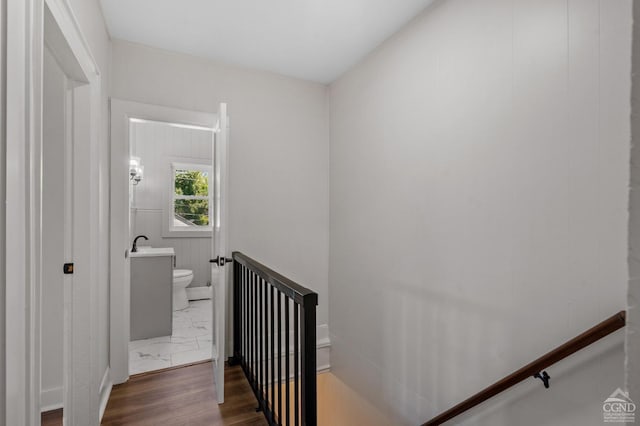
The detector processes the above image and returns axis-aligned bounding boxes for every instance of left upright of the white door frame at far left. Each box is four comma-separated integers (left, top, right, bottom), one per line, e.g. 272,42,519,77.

4,0,39,425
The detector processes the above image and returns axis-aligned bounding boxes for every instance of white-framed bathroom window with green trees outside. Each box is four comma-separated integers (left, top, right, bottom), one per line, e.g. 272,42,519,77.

168,163,213,233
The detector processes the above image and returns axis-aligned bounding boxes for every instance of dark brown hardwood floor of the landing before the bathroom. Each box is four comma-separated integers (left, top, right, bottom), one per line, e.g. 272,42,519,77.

102,362,267,426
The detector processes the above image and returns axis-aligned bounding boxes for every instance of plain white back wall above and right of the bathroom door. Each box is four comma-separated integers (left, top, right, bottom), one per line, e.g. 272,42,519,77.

111,41,329,324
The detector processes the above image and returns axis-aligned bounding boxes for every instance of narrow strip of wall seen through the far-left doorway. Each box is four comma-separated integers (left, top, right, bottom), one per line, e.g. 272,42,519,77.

40,45,66,411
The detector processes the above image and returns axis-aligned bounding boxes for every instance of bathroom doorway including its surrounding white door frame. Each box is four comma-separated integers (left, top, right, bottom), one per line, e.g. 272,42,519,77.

110,99,230,398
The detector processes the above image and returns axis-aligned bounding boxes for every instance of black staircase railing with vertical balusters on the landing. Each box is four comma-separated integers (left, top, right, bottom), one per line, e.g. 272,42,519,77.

230,252,318,426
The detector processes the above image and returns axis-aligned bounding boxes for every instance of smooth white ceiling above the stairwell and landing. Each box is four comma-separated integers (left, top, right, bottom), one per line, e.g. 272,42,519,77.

101,0,433,83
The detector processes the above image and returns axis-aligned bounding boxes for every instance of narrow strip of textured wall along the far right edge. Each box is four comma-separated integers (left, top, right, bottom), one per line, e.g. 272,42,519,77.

627,2,640,403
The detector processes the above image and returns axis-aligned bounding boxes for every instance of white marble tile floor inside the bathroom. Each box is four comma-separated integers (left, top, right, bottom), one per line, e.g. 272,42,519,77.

129,300,213,374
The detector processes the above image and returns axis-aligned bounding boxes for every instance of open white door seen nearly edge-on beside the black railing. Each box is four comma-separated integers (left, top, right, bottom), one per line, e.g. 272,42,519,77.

211,104,230,404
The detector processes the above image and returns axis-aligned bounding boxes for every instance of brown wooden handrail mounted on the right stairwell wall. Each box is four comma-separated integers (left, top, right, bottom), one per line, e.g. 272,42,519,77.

422,311,626,426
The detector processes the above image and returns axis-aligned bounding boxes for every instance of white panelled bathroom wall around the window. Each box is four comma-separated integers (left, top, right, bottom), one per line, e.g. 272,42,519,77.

130,118,213,287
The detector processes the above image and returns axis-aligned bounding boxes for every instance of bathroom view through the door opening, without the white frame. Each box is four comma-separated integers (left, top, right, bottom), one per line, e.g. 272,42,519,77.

129,118,214,375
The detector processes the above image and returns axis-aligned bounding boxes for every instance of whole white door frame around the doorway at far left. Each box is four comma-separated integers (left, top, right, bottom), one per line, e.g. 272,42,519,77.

1,0,101,426
